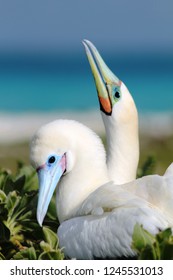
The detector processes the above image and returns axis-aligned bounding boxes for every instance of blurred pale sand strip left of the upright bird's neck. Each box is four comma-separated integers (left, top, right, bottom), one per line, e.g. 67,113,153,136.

0,111,104,144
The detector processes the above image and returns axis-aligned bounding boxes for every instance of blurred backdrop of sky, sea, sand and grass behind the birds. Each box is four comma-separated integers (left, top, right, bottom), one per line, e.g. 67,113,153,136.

0,0,173,174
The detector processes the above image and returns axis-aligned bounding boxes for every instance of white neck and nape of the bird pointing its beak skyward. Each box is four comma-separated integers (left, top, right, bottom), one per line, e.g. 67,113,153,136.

101,83,139,184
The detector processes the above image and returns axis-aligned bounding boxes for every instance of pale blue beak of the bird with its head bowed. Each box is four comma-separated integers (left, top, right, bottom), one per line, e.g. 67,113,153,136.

37,155,65,226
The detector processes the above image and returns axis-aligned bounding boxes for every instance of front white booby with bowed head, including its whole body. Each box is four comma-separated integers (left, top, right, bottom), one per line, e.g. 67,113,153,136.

30,120,173,259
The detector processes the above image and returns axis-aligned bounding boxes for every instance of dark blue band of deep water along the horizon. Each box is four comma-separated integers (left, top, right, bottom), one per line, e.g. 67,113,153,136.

0,50,173,72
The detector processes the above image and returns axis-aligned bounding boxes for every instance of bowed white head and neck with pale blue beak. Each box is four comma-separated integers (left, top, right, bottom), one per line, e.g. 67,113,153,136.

30,120,108,225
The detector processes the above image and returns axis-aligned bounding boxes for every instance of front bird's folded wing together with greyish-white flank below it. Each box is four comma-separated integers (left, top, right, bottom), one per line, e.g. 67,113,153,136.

58,180,170,259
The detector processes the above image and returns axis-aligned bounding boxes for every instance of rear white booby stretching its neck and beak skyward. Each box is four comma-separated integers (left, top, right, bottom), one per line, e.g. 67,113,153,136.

83,40,139,184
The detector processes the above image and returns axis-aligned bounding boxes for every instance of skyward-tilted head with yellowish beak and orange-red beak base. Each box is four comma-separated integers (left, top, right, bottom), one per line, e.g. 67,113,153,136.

83,40,137,122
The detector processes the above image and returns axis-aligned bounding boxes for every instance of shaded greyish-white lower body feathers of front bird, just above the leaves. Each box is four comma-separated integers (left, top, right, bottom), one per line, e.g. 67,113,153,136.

58,201,167,259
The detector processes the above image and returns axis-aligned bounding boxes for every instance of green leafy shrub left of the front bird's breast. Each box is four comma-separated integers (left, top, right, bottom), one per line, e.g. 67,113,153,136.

0,164,64,260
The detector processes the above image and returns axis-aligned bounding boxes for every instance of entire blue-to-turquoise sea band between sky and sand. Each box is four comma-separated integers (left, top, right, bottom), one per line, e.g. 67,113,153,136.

0,53,173,113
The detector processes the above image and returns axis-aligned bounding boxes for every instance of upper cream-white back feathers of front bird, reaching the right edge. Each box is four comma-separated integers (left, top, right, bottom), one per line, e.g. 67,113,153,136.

77,173,173,226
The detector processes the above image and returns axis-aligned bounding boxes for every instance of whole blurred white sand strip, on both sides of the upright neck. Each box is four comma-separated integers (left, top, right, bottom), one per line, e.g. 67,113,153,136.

0,110,173,144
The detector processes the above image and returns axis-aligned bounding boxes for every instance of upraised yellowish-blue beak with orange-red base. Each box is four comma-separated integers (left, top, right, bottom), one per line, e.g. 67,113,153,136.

83,40,121,114
